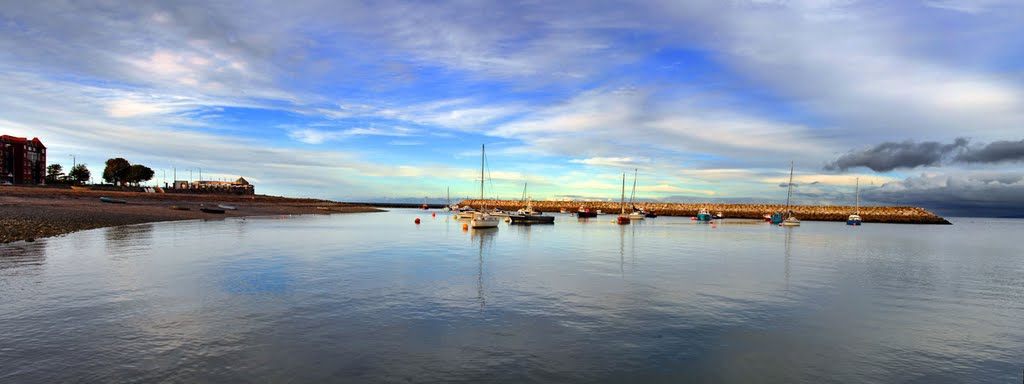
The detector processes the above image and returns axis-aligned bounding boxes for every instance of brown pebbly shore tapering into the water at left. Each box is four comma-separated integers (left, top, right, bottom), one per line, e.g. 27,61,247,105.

0,186,381,243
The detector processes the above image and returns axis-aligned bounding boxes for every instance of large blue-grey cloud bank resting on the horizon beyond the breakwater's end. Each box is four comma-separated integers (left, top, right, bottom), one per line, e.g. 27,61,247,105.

860,172,1024,217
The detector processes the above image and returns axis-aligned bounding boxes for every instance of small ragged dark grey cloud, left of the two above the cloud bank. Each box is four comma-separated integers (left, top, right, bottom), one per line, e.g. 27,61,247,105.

824,137,968,172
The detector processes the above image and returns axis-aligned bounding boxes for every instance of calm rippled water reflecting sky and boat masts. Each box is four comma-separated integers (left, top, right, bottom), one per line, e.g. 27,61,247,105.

0,210,1024,383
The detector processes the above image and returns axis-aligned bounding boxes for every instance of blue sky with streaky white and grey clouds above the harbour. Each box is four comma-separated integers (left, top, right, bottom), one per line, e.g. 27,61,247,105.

0,0,1024,216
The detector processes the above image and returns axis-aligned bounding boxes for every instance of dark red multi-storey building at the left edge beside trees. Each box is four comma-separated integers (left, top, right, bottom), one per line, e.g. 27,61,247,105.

0,135,46,184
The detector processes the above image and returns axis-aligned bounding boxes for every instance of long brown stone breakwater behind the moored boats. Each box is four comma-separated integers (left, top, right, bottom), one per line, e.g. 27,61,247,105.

459,200,949,224
